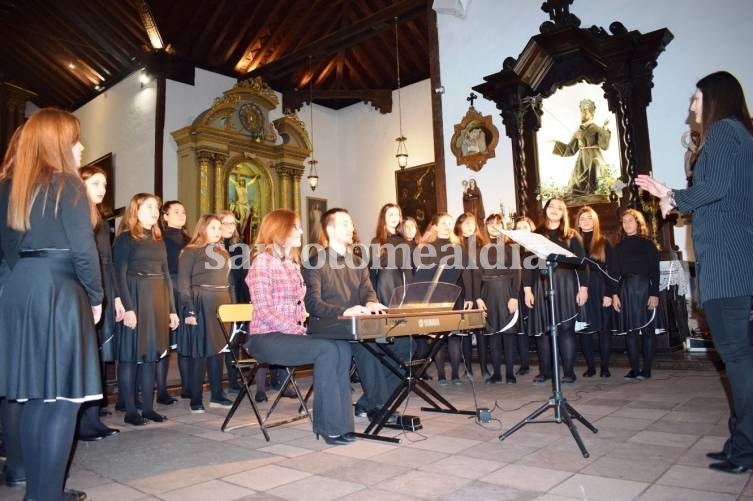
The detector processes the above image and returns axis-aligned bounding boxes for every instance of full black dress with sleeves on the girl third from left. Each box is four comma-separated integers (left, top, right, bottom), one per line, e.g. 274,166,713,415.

113,230,175,362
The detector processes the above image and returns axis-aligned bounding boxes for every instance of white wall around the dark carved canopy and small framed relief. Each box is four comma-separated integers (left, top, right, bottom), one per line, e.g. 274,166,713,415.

437,0,753,256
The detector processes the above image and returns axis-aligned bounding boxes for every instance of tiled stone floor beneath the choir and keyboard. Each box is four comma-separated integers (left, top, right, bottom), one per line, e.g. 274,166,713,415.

0,362,753,501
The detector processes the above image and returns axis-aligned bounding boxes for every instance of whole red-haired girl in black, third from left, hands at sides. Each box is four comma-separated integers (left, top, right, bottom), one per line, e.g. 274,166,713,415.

112,193,179,426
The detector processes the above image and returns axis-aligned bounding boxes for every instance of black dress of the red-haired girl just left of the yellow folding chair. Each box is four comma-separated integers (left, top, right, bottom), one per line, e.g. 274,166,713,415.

178,246,230,358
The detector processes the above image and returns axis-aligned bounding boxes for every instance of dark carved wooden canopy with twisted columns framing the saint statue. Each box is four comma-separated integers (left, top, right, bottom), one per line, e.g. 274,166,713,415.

473,0,673,227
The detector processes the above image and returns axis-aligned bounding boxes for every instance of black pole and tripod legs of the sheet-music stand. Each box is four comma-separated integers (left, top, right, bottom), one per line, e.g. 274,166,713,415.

499,254,599,458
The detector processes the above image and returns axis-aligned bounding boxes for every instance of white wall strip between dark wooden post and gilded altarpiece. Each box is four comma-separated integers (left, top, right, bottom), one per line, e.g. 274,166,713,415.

162,68,237,200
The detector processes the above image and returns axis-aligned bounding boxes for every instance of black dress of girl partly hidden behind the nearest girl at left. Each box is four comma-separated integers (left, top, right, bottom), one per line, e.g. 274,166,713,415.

94,221,120,362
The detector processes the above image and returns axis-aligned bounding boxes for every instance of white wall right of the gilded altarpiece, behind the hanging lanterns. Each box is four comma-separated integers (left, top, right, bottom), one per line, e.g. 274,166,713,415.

336,80,434,238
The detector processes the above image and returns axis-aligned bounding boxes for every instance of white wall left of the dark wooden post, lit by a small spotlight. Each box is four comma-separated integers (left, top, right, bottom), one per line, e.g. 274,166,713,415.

74,72,156,207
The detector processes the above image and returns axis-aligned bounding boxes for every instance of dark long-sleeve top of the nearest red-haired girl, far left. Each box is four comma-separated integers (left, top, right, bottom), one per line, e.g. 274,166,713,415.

0,173,104,305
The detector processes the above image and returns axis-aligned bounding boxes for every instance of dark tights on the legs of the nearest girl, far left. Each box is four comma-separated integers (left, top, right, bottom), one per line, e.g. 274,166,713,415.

21,399,80,501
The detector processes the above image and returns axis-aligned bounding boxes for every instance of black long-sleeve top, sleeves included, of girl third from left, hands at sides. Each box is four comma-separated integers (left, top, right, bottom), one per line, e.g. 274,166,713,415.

112,230,176,313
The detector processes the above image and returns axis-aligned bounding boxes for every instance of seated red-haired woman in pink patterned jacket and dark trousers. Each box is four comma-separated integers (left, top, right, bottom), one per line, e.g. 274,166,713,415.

245,209,355,445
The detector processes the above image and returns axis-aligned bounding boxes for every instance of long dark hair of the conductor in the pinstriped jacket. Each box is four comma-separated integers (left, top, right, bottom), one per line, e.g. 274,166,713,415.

695,71,753,144
